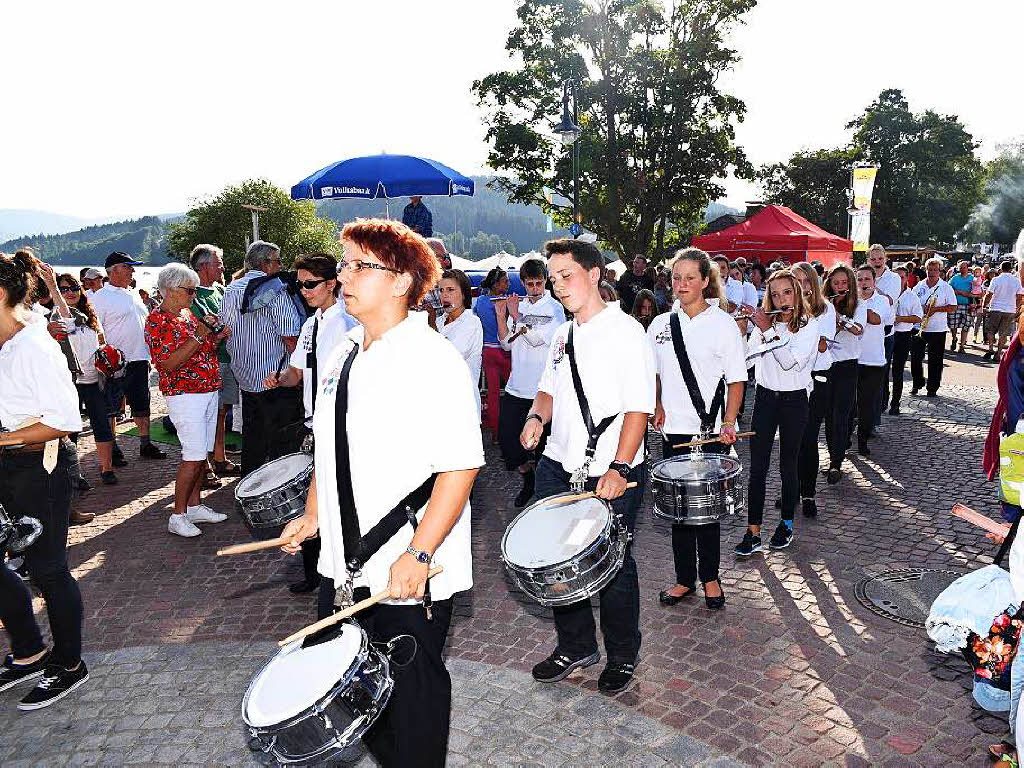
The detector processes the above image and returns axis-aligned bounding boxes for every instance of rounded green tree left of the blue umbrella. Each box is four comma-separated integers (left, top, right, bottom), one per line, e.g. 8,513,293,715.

167,179,341,271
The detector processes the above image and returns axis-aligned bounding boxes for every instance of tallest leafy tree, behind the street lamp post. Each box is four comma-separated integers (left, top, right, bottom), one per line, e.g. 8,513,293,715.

473,0,756,262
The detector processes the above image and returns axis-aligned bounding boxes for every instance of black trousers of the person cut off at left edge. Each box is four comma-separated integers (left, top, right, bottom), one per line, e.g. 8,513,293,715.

0,440,83,669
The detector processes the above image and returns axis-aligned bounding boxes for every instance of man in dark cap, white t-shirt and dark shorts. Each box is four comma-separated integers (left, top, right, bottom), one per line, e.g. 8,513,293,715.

89,251,167,467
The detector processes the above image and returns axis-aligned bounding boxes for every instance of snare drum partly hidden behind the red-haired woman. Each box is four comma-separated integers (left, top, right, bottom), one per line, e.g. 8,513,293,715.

234,453,313,528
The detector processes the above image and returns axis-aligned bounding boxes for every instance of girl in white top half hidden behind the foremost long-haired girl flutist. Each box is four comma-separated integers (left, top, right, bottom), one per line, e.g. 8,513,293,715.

792,261,836,517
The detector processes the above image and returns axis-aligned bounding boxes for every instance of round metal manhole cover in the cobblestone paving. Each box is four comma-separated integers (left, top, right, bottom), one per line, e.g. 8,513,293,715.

855,568,964,629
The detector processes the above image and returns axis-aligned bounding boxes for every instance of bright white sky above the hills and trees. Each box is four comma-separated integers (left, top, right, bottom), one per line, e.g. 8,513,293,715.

0,0,1024,218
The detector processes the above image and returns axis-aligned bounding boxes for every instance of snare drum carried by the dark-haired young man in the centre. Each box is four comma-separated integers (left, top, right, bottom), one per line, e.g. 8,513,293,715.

502,495,630,606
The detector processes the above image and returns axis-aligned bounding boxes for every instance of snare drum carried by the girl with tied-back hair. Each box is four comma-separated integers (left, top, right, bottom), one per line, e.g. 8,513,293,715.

650,454,744,525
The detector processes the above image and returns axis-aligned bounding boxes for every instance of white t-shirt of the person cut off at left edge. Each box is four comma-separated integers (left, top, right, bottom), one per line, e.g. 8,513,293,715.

0,323,82,436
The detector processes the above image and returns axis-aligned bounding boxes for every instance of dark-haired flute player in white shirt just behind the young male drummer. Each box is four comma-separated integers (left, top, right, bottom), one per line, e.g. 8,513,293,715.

495,259,565,507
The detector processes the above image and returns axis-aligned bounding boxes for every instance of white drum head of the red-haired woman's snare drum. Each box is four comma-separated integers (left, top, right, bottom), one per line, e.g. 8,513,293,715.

242,624,362,728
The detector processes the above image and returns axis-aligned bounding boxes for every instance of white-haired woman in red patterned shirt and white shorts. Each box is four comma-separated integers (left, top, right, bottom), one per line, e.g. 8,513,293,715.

144,264,230,537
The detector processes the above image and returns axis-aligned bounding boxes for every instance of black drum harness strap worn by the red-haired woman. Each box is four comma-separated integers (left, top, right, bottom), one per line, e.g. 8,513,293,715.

335,344,437,621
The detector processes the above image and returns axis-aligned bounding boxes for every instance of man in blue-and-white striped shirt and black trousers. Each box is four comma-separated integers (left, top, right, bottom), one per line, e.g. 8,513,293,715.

220,241,304,476
